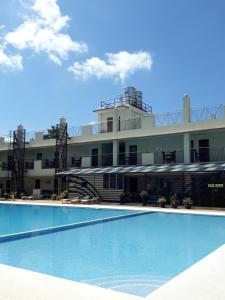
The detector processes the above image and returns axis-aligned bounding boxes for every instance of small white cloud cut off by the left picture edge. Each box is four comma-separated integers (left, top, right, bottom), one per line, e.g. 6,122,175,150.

0,47,23,71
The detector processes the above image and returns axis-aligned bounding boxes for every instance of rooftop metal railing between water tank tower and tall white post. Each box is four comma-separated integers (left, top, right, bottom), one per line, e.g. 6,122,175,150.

155,110,183,127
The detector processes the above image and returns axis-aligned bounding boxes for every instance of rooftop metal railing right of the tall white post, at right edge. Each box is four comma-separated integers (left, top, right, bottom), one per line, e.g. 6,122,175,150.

190,104,223,122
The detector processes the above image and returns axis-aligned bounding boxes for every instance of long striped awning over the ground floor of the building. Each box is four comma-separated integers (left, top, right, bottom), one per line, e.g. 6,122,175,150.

57,163,225,176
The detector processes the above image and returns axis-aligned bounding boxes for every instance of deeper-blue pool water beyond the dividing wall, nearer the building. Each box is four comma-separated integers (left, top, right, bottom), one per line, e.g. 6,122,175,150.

0,204,134,236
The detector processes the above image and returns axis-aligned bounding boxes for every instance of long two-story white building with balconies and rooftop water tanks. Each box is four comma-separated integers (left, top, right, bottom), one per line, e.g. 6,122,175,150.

0,87,225,206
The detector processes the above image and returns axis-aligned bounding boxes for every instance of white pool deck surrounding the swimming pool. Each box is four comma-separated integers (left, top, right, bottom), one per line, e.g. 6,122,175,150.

0,201,225,300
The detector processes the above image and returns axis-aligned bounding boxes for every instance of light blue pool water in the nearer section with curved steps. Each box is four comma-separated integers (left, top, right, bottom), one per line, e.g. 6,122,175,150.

0,209,225,296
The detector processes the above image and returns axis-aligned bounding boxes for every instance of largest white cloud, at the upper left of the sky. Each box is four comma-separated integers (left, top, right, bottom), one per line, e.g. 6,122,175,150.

5,0,87,65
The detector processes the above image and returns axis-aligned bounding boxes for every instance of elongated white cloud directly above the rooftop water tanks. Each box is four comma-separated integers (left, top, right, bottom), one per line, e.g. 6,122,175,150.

68,51,153,82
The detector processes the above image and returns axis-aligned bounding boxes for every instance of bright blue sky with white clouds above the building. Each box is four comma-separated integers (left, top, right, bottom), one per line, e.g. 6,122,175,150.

0,0,225,134
